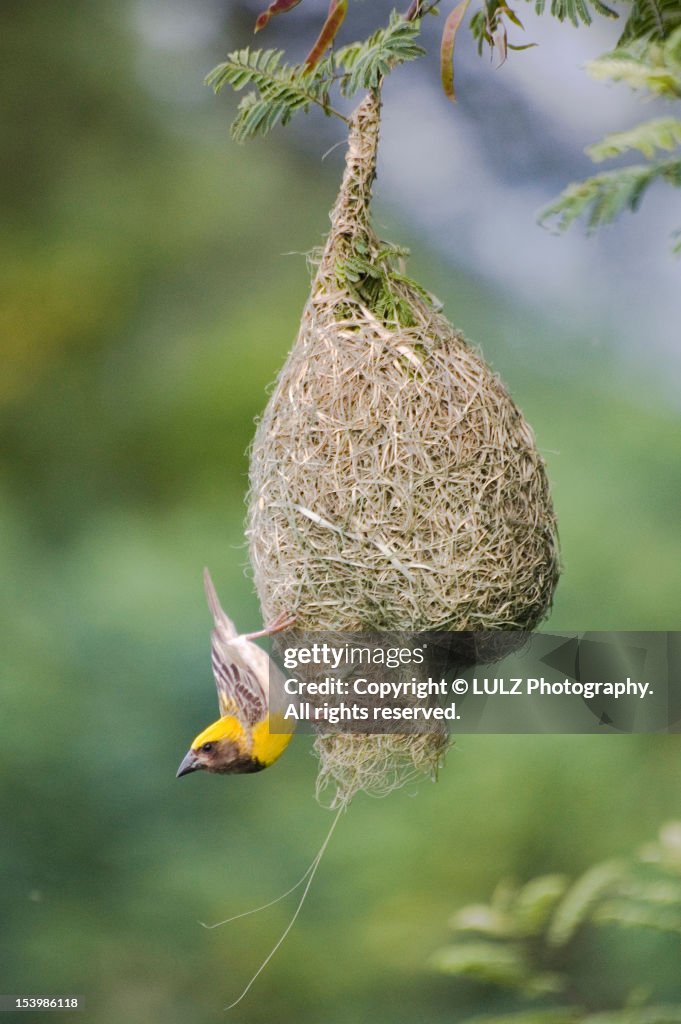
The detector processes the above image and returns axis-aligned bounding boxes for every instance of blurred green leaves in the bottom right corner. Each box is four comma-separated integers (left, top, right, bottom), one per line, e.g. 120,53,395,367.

431,823,681,1024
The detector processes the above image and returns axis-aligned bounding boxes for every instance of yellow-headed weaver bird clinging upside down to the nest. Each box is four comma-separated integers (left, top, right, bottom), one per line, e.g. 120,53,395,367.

177,569,295,778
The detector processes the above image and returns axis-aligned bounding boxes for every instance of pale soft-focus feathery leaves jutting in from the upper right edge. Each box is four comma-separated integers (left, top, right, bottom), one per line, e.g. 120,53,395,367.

540,28,681,251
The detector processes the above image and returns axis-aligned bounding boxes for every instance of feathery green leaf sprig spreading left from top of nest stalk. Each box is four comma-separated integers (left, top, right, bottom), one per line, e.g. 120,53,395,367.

206,13,424,142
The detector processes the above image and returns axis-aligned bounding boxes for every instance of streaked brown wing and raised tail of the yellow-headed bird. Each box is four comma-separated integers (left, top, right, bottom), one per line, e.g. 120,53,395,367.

204,569,269,727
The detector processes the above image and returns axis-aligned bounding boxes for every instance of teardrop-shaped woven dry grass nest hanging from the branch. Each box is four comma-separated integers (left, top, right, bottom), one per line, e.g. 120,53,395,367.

248,94,559,805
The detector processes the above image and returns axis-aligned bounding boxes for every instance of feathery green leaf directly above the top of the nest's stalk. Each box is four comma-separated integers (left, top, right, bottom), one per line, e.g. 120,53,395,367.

336,12,425,96
